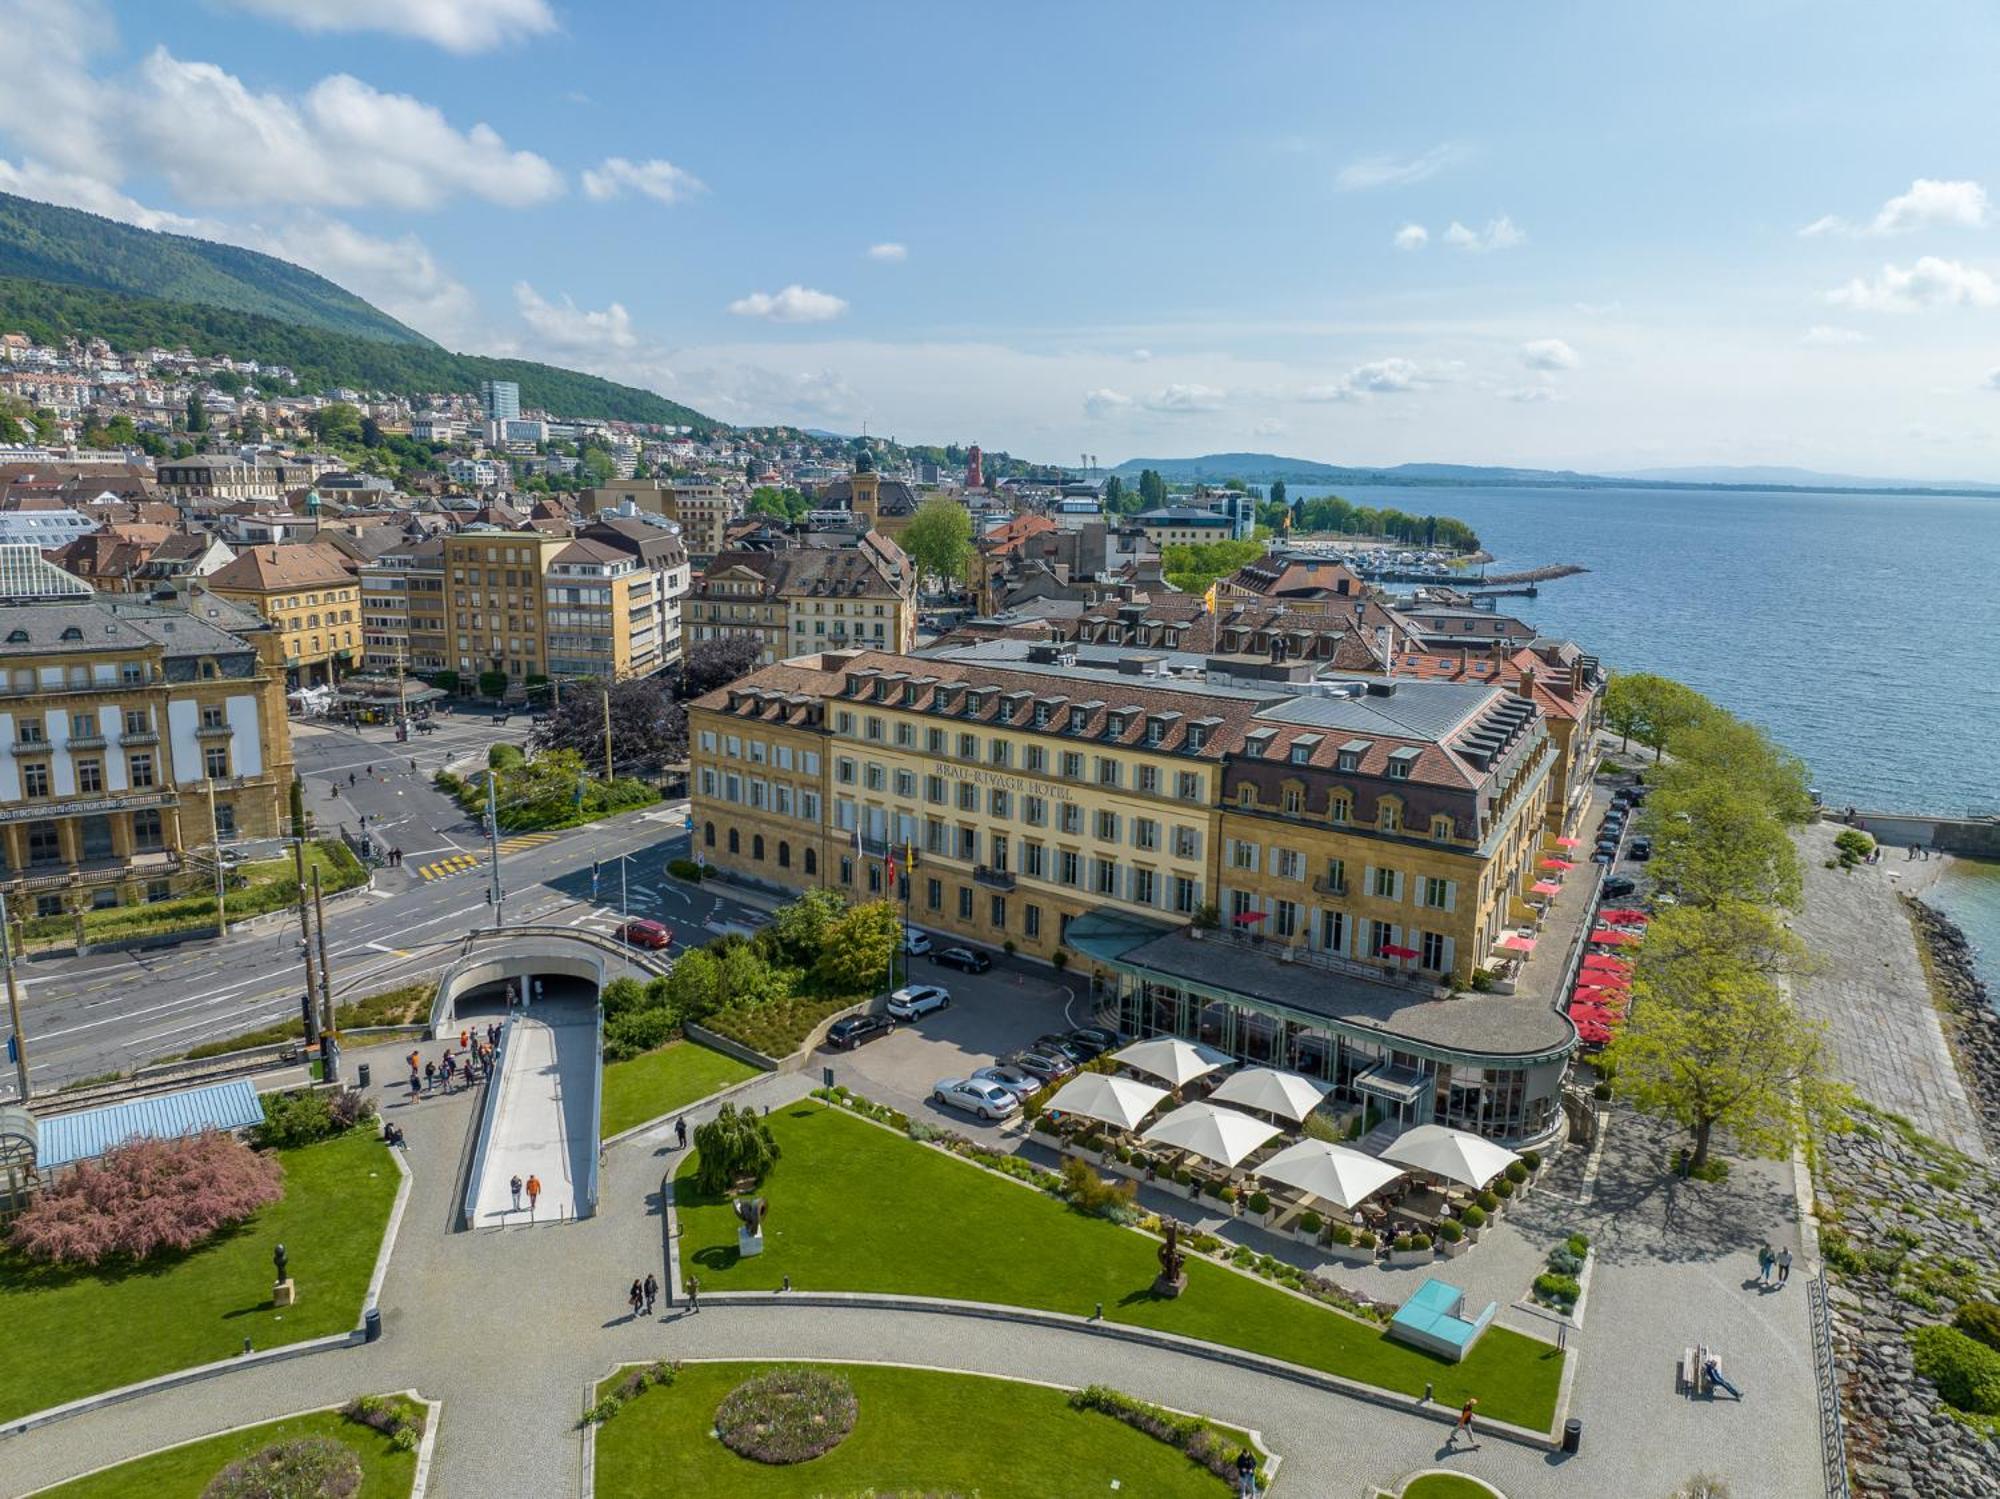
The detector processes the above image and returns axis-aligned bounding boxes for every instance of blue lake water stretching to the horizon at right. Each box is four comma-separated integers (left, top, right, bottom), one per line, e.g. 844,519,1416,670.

1288,486,2000,999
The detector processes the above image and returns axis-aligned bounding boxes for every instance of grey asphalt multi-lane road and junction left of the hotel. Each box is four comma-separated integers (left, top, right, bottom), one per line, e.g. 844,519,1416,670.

0,718,760,1097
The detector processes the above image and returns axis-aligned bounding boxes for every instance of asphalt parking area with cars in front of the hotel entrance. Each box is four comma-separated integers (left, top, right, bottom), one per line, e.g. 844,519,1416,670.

814,957,1090,1149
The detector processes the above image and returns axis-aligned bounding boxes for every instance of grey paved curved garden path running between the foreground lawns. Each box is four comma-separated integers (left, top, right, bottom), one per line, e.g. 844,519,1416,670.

0,1049,1720,1499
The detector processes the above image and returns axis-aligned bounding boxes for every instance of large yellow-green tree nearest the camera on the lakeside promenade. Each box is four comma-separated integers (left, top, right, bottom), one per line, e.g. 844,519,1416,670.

1606,907,1838,1167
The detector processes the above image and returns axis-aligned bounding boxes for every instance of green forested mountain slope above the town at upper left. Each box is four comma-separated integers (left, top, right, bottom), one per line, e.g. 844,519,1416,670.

0,192,718,430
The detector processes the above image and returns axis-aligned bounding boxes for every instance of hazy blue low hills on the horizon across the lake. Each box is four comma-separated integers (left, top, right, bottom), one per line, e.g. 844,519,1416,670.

1112,454,2000,494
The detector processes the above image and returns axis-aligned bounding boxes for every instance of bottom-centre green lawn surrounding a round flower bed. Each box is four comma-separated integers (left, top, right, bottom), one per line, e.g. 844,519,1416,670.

596,1363,1246,1499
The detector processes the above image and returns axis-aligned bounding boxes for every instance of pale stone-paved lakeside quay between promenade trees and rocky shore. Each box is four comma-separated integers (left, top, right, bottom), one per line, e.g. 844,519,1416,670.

1792,823,1988,1161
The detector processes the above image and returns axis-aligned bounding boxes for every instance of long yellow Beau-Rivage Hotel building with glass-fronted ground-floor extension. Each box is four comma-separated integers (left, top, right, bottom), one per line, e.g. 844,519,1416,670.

690,638,1594,1141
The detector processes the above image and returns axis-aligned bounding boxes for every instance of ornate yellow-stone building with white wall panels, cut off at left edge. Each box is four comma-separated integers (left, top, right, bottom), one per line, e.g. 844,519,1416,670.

0,594,292,917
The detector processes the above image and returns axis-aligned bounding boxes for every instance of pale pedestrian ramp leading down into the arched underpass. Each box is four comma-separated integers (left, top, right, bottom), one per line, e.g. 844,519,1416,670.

468,1003,598,1229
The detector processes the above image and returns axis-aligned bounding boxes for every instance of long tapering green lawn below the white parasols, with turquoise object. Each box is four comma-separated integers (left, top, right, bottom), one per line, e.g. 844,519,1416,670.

676,1103,1562,1431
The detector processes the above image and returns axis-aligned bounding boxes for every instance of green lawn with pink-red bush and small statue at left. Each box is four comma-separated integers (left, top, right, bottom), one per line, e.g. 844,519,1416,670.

0,1127,398,1421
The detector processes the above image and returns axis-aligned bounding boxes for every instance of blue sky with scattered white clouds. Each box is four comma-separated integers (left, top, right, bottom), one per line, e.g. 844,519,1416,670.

11,0,2000,480
